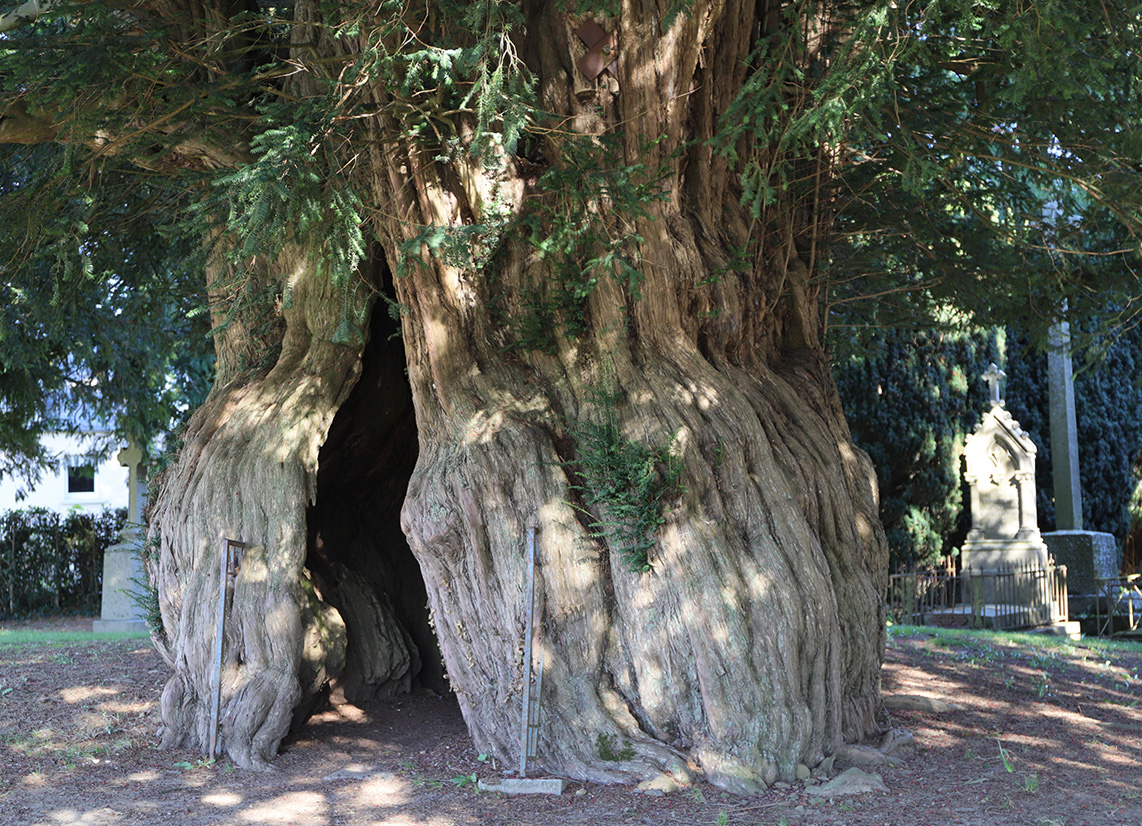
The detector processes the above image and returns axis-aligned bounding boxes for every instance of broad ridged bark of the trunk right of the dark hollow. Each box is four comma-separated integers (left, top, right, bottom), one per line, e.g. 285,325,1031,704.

370,3,886,792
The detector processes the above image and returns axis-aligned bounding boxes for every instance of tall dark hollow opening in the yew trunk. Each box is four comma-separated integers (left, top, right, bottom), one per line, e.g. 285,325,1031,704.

306,281,449,704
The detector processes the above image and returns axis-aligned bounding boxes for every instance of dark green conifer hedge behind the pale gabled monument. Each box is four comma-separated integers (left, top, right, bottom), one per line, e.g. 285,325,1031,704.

835,329,1142,566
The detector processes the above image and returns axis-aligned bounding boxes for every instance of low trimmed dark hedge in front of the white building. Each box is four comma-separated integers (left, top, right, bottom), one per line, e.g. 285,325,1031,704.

0,507,127,619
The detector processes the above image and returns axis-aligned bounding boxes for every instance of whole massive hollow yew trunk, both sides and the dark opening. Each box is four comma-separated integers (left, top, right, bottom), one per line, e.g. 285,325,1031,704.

145,2,886,792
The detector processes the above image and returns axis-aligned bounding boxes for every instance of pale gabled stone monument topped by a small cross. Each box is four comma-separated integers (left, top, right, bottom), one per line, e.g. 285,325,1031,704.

960,364,1047,570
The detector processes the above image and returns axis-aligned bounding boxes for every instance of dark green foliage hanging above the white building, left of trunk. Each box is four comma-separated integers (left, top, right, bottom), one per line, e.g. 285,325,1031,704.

0,138,214,482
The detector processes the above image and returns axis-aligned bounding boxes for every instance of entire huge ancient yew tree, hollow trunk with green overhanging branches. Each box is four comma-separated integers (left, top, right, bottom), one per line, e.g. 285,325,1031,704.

0,0,1129,792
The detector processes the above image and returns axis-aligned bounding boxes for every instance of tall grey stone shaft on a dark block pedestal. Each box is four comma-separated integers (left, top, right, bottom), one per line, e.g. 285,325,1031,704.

1043,322,1121,594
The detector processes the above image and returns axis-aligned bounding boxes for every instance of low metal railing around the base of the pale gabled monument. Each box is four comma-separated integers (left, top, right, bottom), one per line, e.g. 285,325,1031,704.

887,563,1068,631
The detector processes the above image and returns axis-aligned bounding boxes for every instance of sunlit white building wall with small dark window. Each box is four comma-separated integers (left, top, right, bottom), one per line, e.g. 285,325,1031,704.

0,433,128,513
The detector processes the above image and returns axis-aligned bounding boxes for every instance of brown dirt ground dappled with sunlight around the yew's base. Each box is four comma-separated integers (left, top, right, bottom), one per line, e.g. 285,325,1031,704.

0,620,1142,826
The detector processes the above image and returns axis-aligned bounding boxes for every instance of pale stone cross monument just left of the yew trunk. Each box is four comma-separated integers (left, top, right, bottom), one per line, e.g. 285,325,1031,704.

91,440,147,632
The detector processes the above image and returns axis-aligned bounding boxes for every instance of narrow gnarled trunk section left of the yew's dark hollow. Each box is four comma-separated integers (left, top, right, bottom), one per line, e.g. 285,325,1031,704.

151,251,364,767
